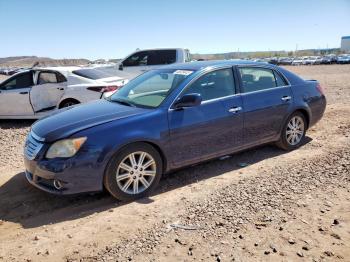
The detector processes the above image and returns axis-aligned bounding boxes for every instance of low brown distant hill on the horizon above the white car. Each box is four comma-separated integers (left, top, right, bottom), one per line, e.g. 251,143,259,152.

0,56,90,67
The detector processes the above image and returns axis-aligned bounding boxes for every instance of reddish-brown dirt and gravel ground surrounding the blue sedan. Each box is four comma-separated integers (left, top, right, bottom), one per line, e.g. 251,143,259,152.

0,65,350,261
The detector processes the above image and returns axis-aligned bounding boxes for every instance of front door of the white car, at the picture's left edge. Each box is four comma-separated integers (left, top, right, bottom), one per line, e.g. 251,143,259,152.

0,71,34,116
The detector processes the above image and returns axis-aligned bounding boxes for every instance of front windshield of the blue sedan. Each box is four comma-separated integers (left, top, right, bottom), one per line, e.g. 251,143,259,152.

109,69,193,108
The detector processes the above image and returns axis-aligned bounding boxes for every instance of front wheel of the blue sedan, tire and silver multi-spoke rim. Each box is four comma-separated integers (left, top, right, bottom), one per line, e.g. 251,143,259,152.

103,143,163,201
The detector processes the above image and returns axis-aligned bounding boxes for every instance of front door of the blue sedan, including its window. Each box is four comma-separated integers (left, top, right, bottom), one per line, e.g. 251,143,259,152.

168,68,243,166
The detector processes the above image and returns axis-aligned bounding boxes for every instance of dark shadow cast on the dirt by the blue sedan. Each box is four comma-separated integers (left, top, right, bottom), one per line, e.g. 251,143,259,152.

0,137,312,228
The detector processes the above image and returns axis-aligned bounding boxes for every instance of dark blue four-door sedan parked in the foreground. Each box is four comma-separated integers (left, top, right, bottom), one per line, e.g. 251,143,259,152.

24,60,326,200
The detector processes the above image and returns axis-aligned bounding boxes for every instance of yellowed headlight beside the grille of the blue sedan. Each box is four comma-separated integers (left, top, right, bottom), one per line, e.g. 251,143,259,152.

46,137,86,158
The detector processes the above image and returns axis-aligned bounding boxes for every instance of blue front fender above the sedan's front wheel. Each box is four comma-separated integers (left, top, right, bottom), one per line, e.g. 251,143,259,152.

74,109,170,185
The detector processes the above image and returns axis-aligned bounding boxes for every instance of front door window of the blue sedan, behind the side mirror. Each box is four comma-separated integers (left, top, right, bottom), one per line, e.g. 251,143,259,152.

183,68,235,101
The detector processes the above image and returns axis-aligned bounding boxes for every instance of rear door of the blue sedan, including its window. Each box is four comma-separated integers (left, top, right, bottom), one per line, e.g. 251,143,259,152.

238,66,292,145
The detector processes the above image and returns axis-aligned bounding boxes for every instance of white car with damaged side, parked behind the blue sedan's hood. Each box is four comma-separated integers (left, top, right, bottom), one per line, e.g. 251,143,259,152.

0,67,128,119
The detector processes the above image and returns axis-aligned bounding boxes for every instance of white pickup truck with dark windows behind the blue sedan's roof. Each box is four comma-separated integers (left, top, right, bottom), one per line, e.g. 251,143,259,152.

117,48,191,76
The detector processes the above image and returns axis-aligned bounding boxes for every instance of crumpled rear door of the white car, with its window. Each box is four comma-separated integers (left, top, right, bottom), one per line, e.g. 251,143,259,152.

30,71,67,112
